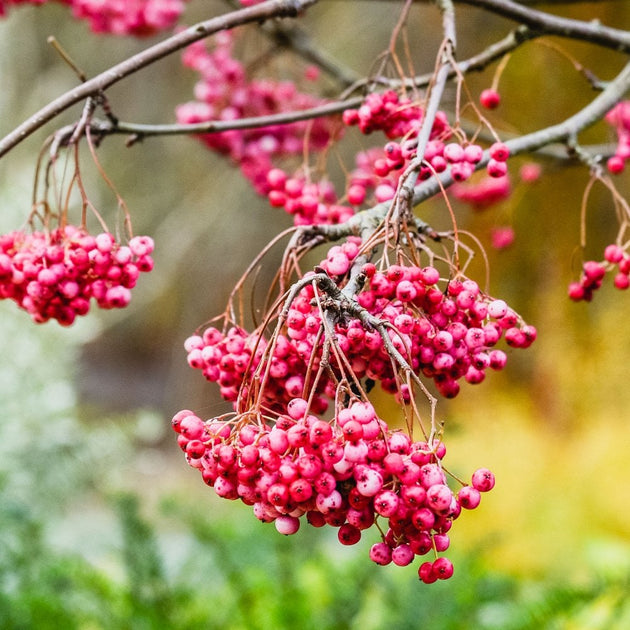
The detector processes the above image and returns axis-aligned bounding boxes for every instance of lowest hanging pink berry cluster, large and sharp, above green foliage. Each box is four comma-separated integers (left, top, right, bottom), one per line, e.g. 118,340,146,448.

172,398,494,583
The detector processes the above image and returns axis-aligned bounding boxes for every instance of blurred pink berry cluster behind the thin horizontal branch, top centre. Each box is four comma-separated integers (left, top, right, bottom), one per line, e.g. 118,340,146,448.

176,31,334,195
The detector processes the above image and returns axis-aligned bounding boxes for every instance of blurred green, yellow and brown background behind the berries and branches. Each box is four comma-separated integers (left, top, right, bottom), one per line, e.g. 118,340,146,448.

0,0,630,630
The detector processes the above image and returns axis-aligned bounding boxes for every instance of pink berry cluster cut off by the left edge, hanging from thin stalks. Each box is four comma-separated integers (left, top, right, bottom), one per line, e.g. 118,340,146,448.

0,226,153,326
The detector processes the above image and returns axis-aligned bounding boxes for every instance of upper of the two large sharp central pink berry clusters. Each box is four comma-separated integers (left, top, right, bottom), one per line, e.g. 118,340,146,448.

185,238,536,404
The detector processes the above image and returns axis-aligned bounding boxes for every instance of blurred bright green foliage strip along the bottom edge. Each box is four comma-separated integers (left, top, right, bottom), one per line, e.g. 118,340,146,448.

0,488,630,630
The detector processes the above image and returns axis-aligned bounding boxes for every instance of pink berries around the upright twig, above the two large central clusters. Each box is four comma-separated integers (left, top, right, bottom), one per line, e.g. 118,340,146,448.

266,91,511,225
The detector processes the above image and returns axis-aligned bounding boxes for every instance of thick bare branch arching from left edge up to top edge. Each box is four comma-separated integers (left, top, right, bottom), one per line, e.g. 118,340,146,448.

0,0,318,157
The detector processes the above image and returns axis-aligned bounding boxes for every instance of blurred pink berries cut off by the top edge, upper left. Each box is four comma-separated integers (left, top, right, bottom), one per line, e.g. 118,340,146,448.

0,0,186,37
